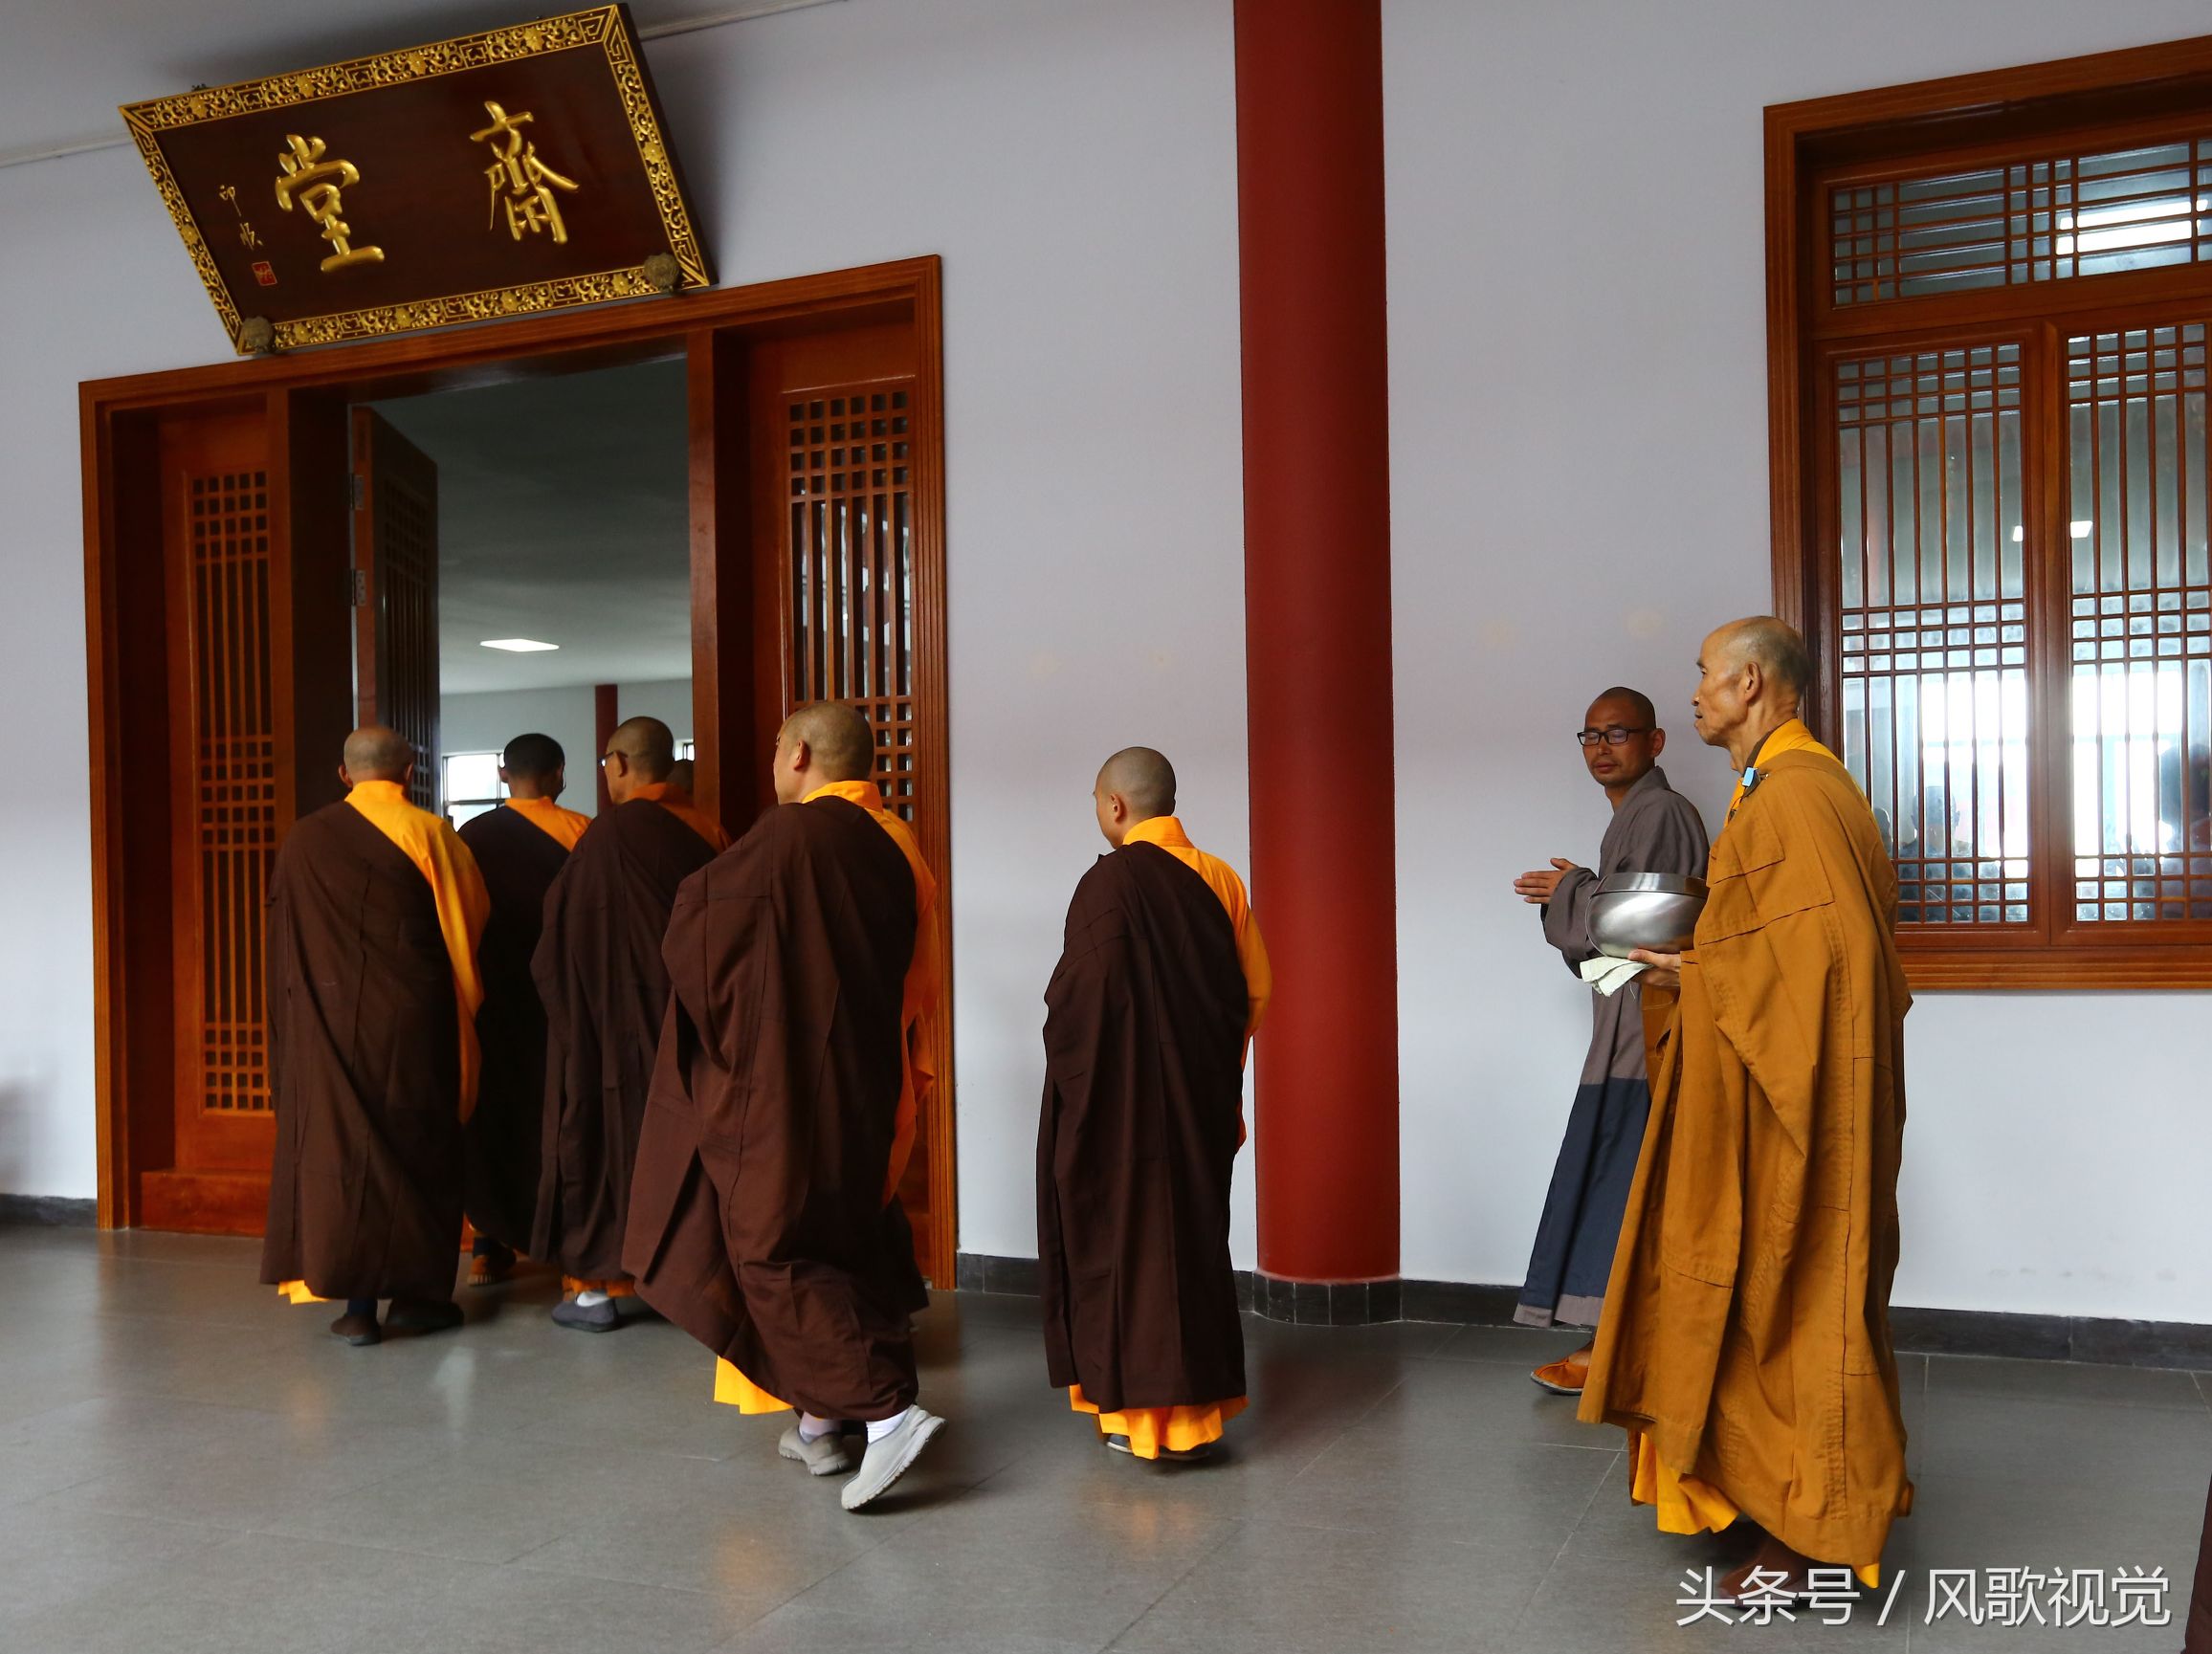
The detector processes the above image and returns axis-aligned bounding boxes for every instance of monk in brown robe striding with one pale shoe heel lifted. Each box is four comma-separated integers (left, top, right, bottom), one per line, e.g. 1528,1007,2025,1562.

624,703,944,1511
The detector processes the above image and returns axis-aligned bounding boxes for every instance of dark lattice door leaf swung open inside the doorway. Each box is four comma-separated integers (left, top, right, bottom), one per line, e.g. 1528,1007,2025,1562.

354,407,442,809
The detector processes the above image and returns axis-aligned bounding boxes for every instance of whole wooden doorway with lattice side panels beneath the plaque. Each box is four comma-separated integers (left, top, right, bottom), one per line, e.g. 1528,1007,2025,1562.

79,258,958,1280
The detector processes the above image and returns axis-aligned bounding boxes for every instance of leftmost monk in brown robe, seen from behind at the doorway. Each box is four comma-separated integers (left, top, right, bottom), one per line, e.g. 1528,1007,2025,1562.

261,727,489,1344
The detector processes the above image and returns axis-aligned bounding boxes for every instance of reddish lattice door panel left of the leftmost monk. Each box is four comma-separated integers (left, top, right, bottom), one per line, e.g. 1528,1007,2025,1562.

164,413,283,1167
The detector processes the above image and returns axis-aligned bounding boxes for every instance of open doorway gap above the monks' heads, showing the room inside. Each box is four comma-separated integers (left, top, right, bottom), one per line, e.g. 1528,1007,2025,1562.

354,356,694,827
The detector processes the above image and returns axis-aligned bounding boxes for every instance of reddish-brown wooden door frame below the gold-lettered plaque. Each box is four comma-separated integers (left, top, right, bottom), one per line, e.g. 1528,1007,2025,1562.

77,256,958,1283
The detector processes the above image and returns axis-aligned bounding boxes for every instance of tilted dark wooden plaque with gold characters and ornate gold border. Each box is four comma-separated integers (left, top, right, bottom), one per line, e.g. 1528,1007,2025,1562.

122,5,715,356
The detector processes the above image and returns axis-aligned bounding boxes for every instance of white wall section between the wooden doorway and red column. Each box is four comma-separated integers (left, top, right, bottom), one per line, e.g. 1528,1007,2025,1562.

653,0,1265,1263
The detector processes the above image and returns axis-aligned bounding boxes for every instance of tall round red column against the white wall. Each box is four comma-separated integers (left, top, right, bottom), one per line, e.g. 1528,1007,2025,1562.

1236,0,1398,1280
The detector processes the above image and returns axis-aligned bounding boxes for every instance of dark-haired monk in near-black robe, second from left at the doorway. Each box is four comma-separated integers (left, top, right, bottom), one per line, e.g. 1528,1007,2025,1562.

460,734,590,1287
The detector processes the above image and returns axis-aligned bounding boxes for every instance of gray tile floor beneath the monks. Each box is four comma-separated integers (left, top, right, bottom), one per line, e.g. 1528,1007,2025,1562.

0,1227,2212,1654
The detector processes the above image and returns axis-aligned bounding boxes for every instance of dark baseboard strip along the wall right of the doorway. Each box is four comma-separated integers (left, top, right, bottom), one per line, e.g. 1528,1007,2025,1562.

951,1246,2212,1371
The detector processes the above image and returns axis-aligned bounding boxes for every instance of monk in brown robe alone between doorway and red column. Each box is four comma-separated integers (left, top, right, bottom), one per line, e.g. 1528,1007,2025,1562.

1037,747,1274,1460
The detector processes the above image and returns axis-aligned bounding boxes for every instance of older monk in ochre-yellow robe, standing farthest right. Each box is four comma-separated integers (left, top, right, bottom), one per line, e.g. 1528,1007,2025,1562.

1580,617,1913,1601
